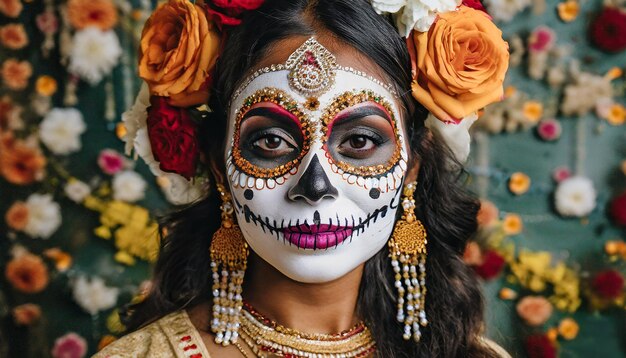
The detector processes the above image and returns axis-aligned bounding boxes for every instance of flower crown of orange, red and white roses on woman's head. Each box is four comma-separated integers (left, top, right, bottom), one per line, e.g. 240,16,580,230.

123,0,509,204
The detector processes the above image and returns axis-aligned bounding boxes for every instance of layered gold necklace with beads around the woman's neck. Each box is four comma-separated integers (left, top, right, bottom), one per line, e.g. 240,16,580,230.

240,302,376,358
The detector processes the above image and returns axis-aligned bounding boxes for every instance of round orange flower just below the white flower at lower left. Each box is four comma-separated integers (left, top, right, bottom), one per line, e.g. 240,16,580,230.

5,252,48,293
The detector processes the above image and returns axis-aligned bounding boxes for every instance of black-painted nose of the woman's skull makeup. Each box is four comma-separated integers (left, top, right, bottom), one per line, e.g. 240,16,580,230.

287,154,338,204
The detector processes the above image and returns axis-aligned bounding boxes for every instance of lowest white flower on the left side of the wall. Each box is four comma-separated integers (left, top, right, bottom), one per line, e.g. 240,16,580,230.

73,276,119,315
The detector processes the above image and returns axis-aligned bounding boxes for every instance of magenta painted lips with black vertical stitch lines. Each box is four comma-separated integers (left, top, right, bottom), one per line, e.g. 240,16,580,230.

283,224,352,250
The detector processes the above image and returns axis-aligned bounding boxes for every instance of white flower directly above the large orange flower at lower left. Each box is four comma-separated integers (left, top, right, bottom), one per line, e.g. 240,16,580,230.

24,194,61,239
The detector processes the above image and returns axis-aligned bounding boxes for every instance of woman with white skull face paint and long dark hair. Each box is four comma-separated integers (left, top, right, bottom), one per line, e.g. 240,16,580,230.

96,0,508,357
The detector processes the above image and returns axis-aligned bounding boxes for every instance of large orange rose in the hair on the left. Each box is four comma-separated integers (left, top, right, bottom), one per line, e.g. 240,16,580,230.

139,0,220,107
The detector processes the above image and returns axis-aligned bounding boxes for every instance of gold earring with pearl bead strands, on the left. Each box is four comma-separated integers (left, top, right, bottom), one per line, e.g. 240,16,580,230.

211,184,248,346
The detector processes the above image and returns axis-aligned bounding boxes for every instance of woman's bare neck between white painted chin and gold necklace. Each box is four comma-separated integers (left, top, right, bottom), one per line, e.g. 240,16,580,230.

243,253,363,334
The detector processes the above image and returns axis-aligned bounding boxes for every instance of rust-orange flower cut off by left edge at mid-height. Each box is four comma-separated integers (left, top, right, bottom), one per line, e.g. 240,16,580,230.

0,134,46,185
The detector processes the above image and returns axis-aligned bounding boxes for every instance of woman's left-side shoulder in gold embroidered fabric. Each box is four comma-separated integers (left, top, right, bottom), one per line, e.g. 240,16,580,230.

93,310,209,358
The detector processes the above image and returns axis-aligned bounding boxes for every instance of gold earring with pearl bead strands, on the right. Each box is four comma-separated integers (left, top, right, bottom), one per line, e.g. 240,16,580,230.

388,182,428,341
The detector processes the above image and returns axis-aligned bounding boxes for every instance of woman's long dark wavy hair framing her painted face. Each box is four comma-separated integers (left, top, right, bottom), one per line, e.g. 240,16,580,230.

128,0,496,357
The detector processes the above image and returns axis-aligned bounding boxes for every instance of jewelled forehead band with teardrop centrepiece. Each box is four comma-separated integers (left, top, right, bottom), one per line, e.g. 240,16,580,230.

231,37,398,99
